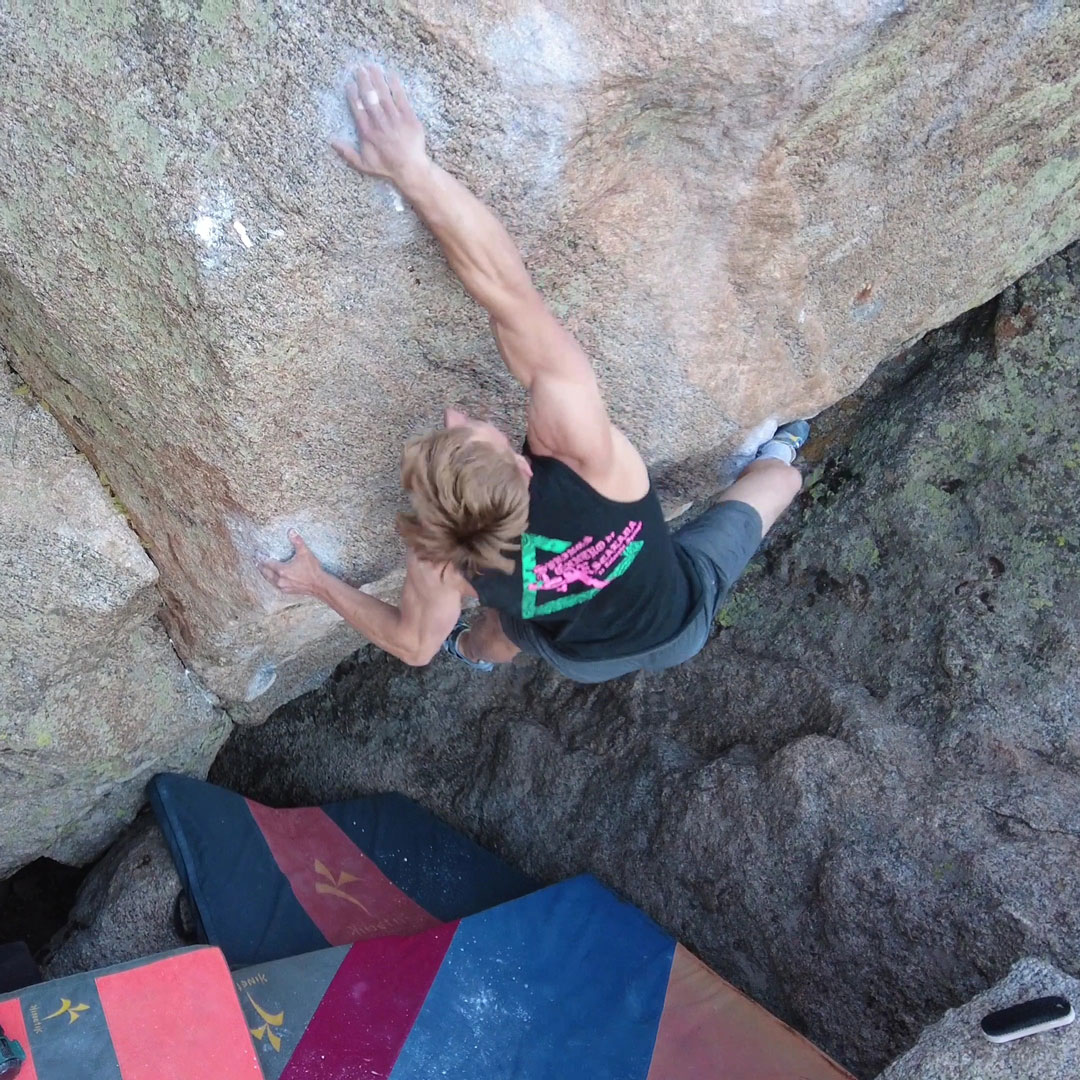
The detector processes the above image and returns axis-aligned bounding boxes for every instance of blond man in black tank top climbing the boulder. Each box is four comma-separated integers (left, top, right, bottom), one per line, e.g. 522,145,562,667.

260,66,810,683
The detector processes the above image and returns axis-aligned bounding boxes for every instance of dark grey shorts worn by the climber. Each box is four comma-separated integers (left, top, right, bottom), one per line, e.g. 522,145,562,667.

500,500,761,683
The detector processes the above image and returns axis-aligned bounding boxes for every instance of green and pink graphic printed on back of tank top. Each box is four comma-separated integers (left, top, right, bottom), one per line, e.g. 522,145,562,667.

522,522,645,619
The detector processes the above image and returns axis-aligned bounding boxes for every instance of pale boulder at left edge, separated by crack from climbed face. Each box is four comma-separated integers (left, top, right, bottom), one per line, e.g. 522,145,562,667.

0,353,229,877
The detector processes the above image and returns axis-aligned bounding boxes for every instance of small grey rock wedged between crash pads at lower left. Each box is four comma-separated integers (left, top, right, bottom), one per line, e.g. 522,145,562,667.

42,816,185,978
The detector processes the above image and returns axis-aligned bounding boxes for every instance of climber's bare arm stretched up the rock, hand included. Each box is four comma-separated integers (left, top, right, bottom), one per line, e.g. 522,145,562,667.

334,67,648,498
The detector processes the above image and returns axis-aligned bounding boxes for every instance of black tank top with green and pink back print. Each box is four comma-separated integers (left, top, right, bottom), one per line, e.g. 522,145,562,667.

472,446,701,660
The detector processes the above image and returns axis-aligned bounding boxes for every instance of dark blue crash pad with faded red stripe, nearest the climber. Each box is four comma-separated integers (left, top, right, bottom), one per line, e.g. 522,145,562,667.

148,773,537,967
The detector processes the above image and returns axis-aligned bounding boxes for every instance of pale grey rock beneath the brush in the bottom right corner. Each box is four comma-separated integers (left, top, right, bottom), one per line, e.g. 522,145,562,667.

878,957,1080,1080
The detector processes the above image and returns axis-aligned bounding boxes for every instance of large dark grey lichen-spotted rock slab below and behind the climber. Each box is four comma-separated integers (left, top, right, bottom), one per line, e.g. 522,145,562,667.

212,247,1080,1077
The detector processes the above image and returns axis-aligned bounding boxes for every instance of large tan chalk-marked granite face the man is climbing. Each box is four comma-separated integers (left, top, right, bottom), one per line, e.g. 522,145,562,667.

0,0,1080,718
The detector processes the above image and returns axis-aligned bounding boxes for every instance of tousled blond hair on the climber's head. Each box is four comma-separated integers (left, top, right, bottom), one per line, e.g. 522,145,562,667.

397,427,529,578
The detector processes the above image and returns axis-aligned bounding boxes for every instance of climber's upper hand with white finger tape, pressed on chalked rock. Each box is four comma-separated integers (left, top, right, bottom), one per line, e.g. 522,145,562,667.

330,64,428,188
